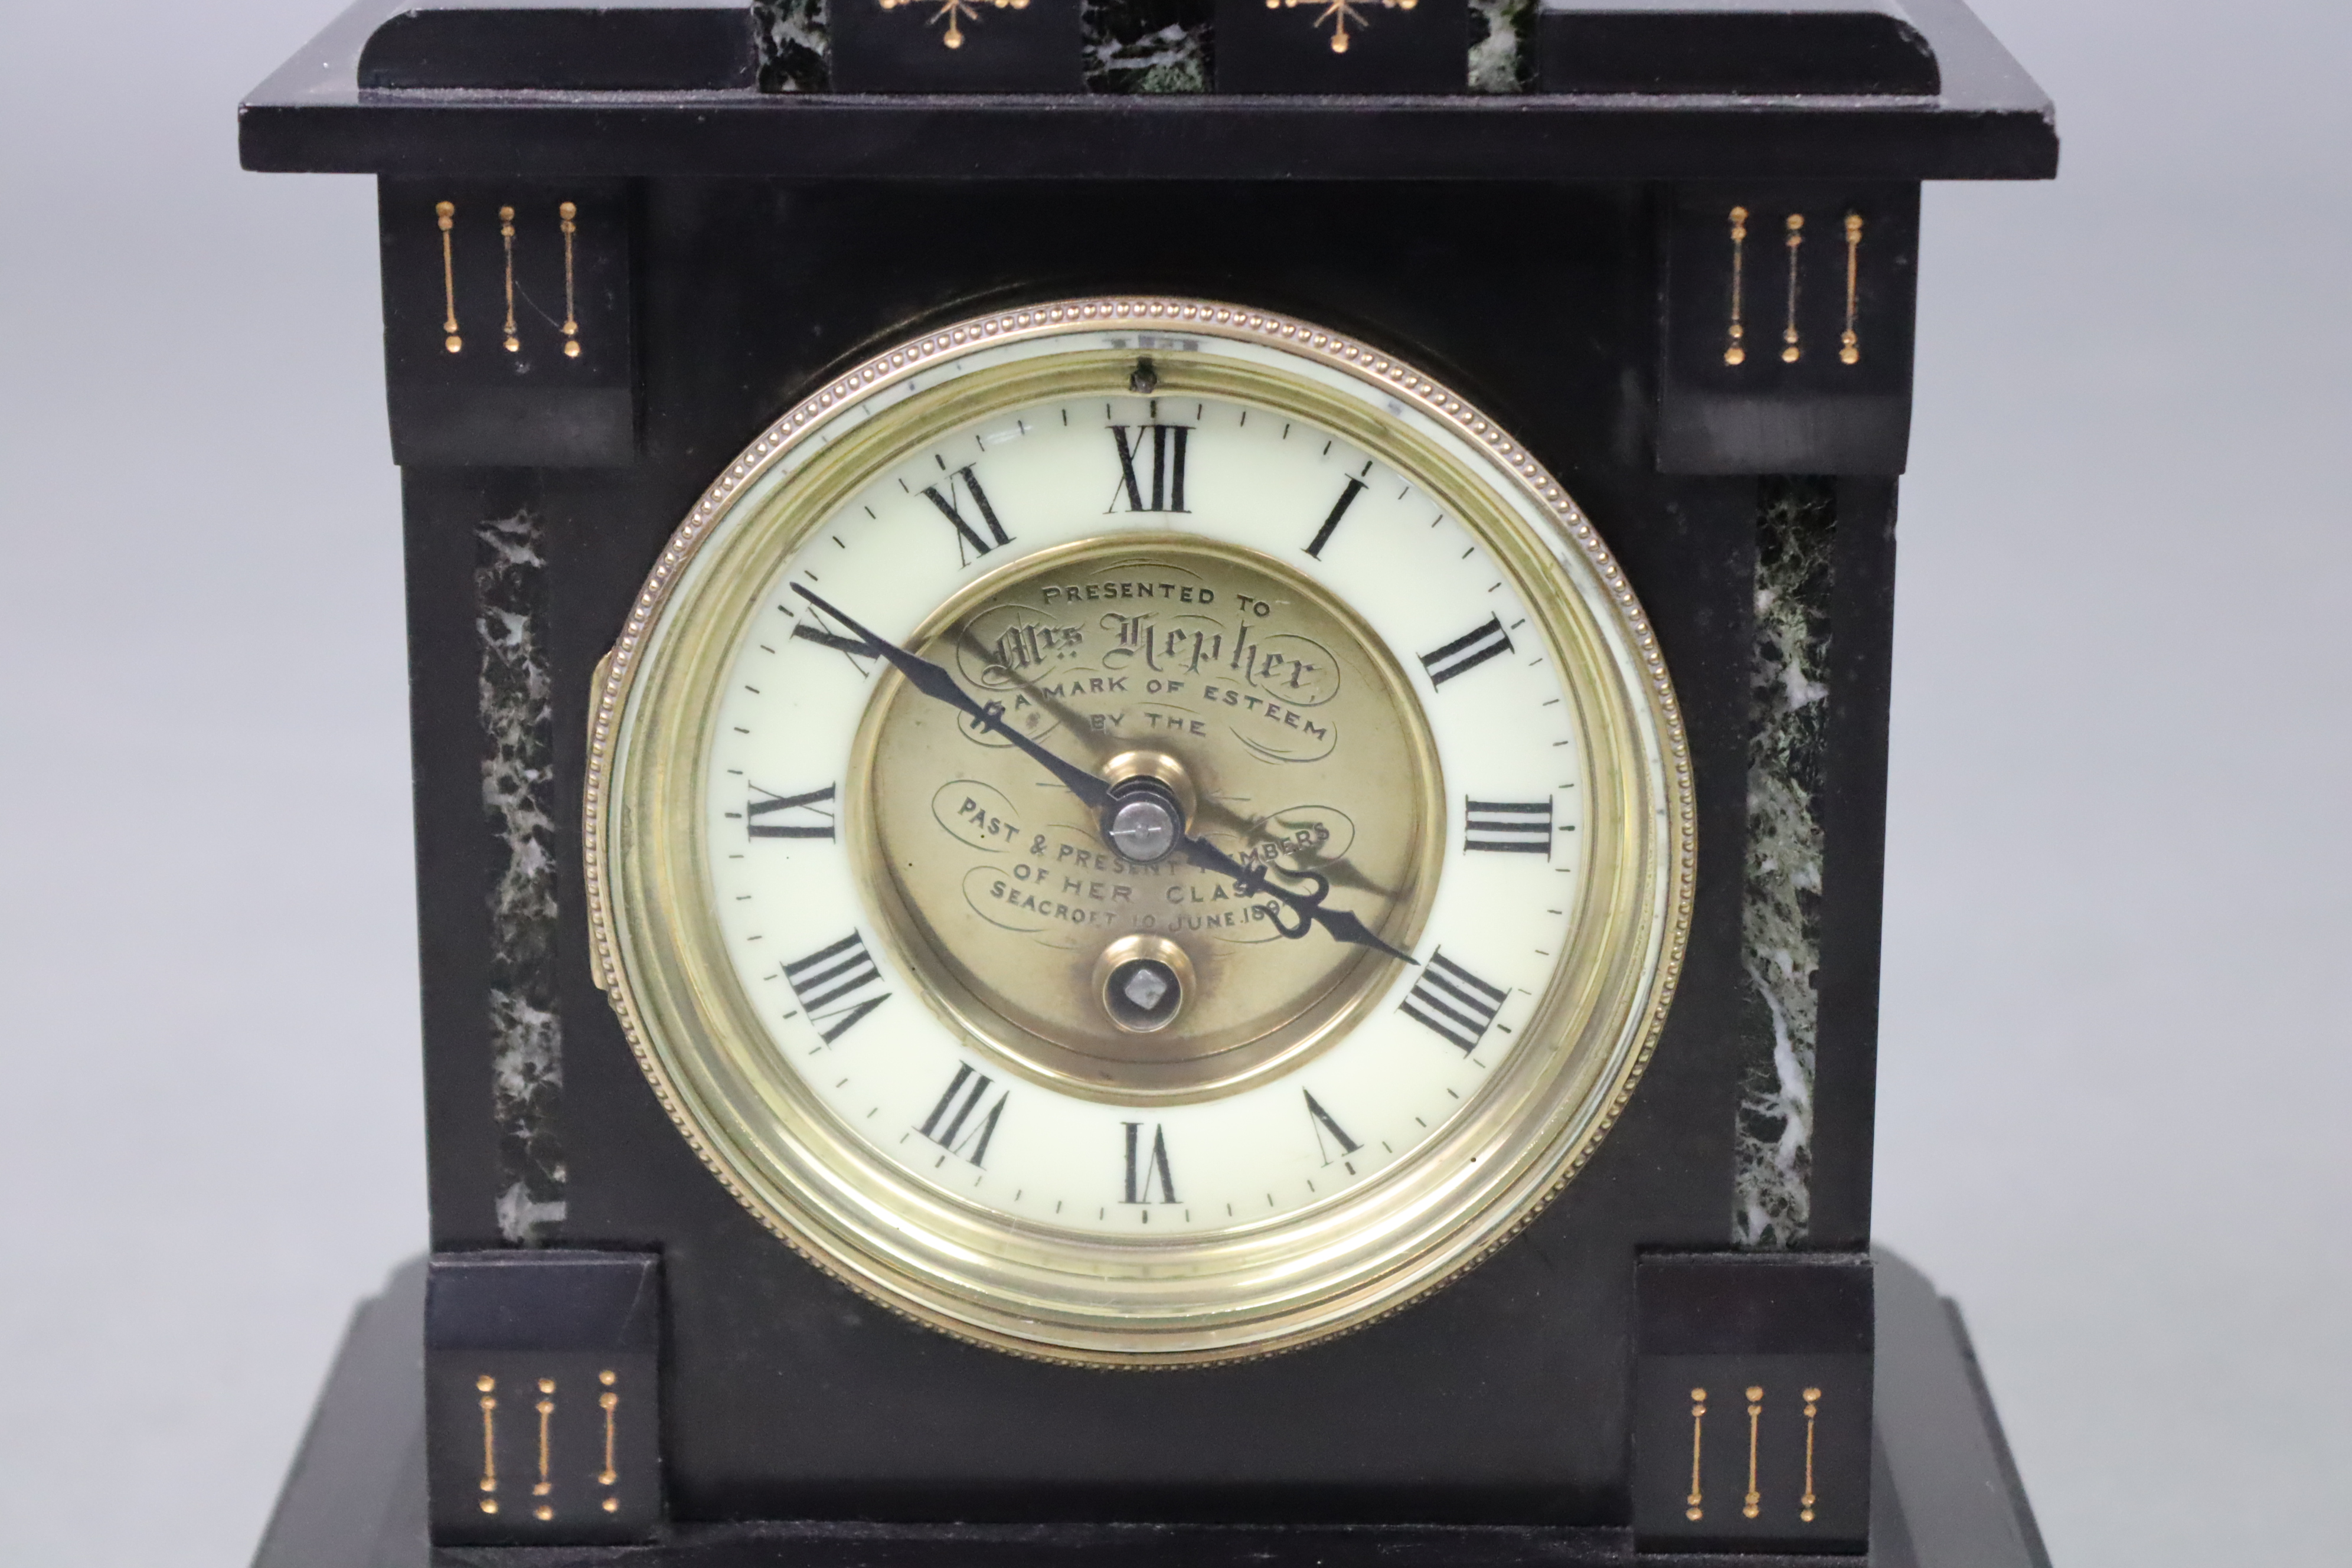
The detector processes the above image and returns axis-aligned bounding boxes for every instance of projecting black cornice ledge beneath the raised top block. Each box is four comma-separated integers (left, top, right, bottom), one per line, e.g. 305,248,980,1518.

237,0,2058,181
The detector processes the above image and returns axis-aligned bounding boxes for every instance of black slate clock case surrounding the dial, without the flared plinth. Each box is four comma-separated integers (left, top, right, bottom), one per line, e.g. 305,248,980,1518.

242,0,2056,1561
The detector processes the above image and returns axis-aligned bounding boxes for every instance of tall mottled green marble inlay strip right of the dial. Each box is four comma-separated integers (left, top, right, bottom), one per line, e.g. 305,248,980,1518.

1731,479,1837,1248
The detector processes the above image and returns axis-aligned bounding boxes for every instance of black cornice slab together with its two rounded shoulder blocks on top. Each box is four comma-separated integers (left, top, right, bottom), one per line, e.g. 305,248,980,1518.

240,0,2058,181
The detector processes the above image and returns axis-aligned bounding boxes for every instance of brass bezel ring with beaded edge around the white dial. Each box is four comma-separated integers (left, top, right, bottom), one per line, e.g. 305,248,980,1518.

583,299,1696,1368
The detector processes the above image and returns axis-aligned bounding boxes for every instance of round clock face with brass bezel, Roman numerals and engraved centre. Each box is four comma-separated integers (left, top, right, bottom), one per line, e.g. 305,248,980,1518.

586,299,1693,1366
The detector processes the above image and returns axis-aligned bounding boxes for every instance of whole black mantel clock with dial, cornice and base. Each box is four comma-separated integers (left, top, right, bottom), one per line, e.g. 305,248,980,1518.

242,0,2056,1566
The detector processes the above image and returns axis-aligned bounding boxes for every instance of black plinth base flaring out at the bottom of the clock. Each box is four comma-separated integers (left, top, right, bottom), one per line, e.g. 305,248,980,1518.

254,1250,2049,1568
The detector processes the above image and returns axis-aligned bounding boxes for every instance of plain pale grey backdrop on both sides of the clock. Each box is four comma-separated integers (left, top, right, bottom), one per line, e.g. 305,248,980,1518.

0,0,2352,1568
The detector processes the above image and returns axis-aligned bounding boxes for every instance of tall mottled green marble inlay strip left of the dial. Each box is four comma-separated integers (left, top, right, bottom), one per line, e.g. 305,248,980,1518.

473,512,564,1246
